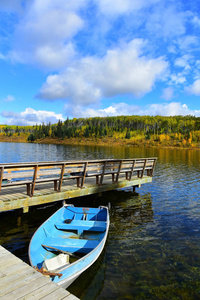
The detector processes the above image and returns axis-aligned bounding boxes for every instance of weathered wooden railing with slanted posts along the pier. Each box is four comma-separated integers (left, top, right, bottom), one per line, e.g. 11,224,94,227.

0,157,157,197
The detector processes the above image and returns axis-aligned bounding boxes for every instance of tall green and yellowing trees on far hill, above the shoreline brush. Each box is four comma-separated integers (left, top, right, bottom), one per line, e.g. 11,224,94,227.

25,116,200,142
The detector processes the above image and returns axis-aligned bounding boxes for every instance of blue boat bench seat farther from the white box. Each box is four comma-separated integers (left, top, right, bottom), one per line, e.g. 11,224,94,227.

55,220,106,233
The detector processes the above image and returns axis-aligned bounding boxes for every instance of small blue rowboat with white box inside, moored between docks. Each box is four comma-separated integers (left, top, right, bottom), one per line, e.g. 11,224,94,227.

29,204,110,288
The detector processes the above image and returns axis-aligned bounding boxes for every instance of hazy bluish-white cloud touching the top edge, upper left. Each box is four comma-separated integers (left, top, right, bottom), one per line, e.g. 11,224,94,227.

9,0,86,70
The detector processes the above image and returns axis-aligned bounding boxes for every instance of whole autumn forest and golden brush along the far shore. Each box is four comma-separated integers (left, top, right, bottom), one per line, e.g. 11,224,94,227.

0,115,200,148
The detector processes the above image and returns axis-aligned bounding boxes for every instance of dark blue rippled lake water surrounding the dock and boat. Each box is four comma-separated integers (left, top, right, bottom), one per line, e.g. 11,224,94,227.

0,143,200,300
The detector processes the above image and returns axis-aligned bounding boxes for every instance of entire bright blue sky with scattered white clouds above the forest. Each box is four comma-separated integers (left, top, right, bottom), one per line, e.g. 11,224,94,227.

0,0,200,125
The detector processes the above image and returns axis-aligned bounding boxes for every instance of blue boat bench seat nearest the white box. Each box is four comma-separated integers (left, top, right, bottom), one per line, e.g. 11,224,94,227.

43,237,99,253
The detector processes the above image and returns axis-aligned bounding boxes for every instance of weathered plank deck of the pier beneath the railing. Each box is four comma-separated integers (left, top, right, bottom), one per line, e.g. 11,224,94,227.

0,175,152,212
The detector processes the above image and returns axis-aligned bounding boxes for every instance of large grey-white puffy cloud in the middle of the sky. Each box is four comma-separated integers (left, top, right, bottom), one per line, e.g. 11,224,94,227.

39,39,168,105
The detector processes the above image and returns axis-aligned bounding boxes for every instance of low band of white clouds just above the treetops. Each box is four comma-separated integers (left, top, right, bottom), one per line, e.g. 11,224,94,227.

1,102,200,126
